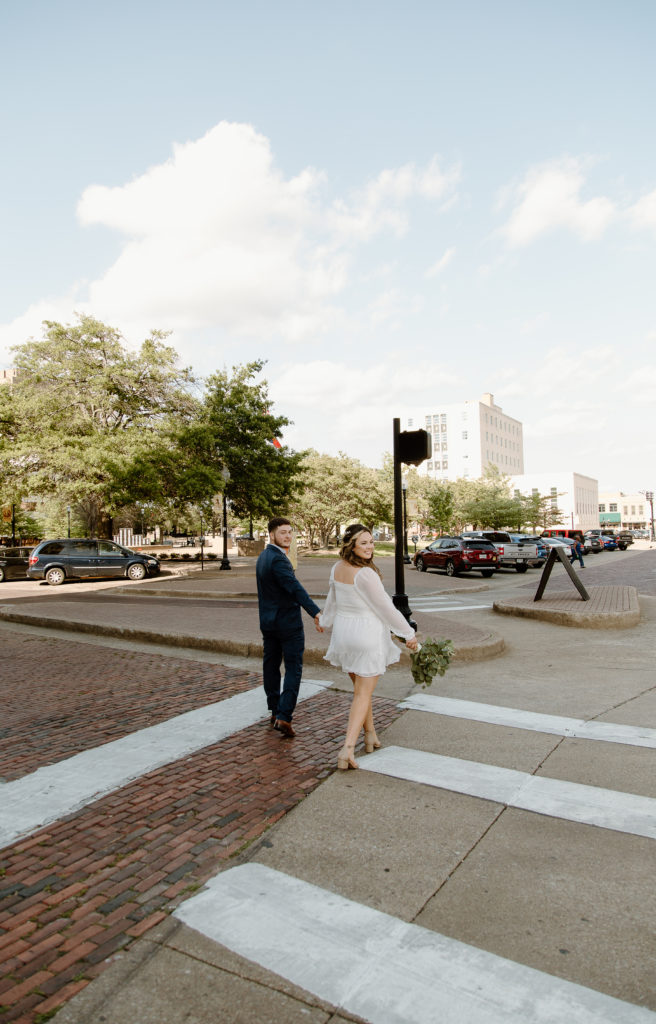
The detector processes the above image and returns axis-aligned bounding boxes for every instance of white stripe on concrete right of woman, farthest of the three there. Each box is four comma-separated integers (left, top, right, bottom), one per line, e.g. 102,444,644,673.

399,693,656,748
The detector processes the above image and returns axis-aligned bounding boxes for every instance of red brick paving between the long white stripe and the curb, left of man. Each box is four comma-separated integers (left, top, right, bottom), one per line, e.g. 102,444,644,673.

0,633,260,781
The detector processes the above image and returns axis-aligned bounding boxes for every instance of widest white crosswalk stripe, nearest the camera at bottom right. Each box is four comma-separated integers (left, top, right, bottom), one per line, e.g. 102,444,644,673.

174,863,656,1024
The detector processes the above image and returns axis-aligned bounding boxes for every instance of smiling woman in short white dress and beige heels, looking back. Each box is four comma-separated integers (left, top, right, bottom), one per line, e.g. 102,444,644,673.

319,523,417,769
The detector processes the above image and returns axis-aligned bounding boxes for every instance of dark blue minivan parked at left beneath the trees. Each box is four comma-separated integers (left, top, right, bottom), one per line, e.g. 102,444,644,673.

28,538,160,587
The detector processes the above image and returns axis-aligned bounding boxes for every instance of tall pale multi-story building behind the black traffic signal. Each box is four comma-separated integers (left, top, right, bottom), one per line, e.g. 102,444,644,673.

403,393,524,480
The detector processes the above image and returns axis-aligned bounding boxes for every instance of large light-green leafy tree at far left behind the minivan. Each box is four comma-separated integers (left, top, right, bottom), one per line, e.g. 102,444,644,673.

0,315,196,536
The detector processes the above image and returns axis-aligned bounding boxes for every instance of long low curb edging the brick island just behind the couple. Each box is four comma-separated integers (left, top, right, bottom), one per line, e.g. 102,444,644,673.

0,607,506,665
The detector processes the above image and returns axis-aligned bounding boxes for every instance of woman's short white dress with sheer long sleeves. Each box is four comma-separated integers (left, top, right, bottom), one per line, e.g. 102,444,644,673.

319,562,414,677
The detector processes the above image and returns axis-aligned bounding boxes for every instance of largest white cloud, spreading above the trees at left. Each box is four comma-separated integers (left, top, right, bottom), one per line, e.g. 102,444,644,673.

4,122,457,356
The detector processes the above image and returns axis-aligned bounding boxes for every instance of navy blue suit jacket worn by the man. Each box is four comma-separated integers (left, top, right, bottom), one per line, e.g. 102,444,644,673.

255,544,321,633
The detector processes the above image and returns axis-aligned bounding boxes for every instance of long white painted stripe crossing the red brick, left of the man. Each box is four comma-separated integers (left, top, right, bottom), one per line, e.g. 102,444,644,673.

0,679,331,849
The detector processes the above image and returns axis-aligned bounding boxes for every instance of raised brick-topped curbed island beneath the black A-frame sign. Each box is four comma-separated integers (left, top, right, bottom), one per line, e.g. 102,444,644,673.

492,587,641,630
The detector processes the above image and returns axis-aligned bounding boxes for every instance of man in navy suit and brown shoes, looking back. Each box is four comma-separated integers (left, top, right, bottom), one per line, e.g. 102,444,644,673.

255,516,323,737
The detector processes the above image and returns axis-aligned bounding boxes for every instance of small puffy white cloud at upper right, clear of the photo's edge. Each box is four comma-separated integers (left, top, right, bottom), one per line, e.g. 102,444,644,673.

501,158,617,247
